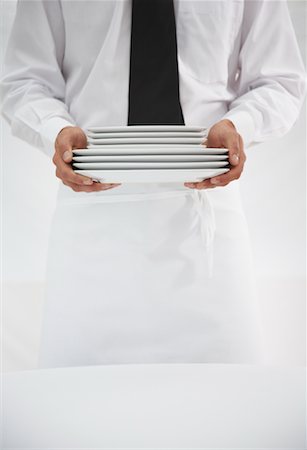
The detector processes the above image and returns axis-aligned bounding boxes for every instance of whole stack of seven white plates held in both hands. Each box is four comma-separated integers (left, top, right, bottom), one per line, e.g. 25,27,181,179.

72,125,229,183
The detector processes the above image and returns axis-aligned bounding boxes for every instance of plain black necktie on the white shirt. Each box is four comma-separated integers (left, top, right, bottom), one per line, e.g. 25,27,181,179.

128,0,184,125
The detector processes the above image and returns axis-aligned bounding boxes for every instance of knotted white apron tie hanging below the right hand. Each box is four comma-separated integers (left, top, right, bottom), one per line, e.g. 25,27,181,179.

192,189,216,278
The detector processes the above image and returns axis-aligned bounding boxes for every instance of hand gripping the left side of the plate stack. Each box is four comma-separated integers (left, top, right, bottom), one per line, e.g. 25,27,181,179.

52,127,120,192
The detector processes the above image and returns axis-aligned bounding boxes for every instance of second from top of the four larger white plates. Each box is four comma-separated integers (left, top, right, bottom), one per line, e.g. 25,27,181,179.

73,155,228,163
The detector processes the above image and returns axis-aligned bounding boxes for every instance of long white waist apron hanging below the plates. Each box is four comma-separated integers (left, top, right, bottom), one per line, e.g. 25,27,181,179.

39,181,264,368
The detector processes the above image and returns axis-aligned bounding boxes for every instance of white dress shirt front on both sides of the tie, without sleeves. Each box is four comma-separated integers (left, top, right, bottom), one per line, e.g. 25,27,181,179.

61,0,244,128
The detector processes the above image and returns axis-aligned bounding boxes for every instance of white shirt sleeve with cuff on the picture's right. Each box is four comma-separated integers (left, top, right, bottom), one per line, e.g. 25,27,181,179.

223,0,306,146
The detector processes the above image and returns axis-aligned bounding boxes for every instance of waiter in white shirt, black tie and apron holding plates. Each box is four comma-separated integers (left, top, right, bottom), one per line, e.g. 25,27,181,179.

1,0,306,367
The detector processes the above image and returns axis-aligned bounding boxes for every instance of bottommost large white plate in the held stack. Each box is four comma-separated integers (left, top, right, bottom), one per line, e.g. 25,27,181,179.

76,169,229,183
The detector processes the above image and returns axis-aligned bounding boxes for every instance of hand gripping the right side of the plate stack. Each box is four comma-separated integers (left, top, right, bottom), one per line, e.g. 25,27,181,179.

184,119,246,189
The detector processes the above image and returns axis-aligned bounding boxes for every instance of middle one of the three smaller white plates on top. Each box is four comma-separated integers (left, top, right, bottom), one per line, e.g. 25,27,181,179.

87,131,205,139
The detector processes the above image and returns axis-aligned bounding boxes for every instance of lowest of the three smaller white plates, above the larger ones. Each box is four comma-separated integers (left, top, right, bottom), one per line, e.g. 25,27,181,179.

87,136,204,145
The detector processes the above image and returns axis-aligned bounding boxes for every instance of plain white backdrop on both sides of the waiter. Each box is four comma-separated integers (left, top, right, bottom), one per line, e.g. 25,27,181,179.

0,0,307,370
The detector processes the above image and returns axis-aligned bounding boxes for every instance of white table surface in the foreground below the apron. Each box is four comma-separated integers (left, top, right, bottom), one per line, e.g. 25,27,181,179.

1,364,306,450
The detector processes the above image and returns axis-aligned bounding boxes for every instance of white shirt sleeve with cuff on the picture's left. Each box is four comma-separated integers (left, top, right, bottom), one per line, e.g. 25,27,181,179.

0,0,75,157
